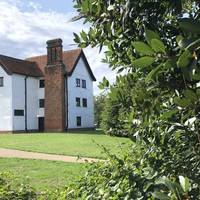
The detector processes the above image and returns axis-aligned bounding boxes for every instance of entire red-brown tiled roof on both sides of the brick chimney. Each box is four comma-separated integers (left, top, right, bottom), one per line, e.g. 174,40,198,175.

0,49,96,81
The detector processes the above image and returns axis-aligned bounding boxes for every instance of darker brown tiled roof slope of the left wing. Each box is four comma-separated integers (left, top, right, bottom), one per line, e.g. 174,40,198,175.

0,55,43,77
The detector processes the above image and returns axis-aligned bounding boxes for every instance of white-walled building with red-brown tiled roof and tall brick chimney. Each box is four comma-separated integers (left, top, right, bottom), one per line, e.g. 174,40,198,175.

0,39,96,132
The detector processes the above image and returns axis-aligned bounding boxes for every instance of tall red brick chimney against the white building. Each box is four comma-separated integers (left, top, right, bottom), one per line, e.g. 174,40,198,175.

45,39,66,132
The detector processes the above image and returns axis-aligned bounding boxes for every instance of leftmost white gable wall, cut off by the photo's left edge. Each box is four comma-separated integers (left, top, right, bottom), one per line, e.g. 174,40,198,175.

0,66,13,131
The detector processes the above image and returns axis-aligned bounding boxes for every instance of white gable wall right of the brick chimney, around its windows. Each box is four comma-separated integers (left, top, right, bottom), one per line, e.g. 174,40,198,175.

68,58,94,129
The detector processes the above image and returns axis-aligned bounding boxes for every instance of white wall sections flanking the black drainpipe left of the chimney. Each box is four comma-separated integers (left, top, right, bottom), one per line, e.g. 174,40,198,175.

12,74,39,131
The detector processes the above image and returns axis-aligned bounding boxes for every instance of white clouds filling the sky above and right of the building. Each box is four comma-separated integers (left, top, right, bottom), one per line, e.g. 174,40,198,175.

0,0,115,94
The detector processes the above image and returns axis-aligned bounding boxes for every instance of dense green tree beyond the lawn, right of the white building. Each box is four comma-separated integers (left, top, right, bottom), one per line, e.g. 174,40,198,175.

100,74,134,136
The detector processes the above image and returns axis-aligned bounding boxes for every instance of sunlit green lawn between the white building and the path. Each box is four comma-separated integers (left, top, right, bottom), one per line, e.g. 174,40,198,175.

0,131,131,158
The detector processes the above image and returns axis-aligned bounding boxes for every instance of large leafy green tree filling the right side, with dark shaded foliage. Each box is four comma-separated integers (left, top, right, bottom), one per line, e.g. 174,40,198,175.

70,0,200,199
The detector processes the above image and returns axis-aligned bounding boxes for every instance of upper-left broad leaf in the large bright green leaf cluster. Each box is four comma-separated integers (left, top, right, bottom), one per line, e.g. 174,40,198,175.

133,42,154,56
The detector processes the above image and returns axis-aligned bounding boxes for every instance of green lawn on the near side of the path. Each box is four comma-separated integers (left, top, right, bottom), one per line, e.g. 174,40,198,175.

0,158,86,191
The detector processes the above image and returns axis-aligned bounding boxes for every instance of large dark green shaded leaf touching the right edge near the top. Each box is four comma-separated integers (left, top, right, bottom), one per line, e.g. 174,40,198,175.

178,18,200,33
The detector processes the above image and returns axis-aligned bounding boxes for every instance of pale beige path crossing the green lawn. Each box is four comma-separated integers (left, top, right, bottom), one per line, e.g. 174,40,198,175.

0,148,100,163
